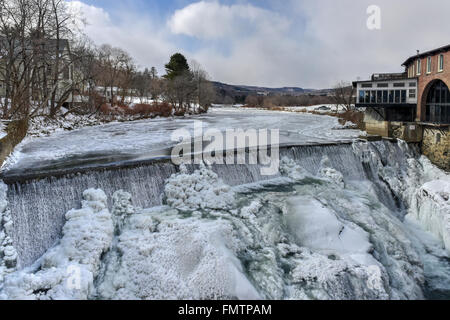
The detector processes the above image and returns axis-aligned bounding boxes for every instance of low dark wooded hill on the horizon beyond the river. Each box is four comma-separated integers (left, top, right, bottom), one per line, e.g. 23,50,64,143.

212,81,332,103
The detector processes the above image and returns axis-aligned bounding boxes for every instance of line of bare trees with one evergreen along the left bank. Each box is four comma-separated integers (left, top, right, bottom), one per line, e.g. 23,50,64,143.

0,0,215,119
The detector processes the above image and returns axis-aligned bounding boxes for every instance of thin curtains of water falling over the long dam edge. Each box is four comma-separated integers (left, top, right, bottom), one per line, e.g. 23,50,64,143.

3,141,418,267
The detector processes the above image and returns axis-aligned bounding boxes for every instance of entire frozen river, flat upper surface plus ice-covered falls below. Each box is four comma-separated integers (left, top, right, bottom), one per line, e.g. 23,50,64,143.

0,108,450,300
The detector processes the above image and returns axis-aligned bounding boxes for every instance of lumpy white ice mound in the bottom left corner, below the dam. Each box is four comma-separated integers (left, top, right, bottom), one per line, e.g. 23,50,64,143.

0,189,114,300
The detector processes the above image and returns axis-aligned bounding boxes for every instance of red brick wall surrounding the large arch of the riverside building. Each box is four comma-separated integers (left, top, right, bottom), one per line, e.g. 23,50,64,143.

406,51,450,121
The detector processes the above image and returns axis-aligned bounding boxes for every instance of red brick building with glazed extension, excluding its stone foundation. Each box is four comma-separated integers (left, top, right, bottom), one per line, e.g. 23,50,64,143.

353,45,450,124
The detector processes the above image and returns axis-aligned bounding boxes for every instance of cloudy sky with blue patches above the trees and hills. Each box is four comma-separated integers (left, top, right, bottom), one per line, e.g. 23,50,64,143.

70,0,450,88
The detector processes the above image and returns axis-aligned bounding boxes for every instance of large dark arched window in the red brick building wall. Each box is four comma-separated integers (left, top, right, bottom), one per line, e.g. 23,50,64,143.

426,80,450,124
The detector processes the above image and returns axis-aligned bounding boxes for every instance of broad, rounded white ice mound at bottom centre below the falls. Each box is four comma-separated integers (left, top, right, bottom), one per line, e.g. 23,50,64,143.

98,207,260,300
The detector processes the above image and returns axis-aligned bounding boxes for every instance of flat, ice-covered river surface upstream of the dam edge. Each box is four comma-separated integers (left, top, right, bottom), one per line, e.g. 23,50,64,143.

2,108,361,175
